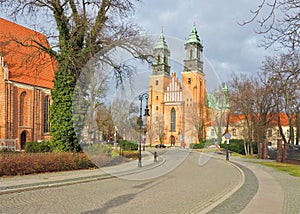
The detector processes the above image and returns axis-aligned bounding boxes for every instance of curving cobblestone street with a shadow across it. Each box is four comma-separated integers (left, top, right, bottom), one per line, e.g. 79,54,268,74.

0,150,242,213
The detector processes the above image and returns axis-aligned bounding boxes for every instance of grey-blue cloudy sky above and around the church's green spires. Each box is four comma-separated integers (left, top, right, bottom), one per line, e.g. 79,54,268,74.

134,0,271,84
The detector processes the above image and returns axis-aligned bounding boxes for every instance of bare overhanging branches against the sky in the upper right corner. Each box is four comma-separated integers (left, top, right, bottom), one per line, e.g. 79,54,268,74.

240,0,300,51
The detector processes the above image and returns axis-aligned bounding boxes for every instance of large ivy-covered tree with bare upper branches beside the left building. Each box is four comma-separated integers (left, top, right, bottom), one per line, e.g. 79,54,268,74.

1,0,149,151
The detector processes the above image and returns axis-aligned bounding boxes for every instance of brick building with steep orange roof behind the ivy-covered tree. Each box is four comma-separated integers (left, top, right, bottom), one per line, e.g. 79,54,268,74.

0,18,56,150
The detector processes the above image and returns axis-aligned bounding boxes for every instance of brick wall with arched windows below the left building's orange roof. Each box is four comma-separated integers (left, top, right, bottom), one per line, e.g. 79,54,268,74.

0,81,50,150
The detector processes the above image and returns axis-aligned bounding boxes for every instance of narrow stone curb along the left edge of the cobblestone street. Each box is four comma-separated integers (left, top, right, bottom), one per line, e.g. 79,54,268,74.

0,156,166,195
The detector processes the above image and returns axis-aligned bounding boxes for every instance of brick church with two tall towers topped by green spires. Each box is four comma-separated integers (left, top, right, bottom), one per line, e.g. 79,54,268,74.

147,26,206,146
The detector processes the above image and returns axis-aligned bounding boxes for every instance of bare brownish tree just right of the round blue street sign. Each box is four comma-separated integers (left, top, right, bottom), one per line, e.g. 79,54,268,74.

230,75,273,155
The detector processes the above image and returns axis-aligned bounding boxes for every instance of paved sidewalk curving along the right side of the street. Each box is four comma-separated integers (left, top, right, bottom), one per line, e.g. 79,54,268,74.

205,156,289,214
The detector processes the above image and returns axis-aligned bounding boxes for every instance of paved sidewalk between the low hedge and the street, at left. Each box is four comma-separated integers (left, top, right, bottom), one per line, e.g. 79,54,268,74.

0,151,164,195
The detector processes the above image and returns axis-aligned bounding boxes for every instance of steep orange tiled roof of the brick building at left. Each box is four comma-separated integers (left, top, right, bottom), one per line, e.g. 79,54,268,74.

0,18,56,89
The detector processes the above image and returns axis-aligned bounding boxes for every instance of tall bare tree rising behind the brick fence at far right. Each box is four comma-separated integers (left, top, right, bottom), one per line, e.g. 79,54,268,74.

262,53,300,144
